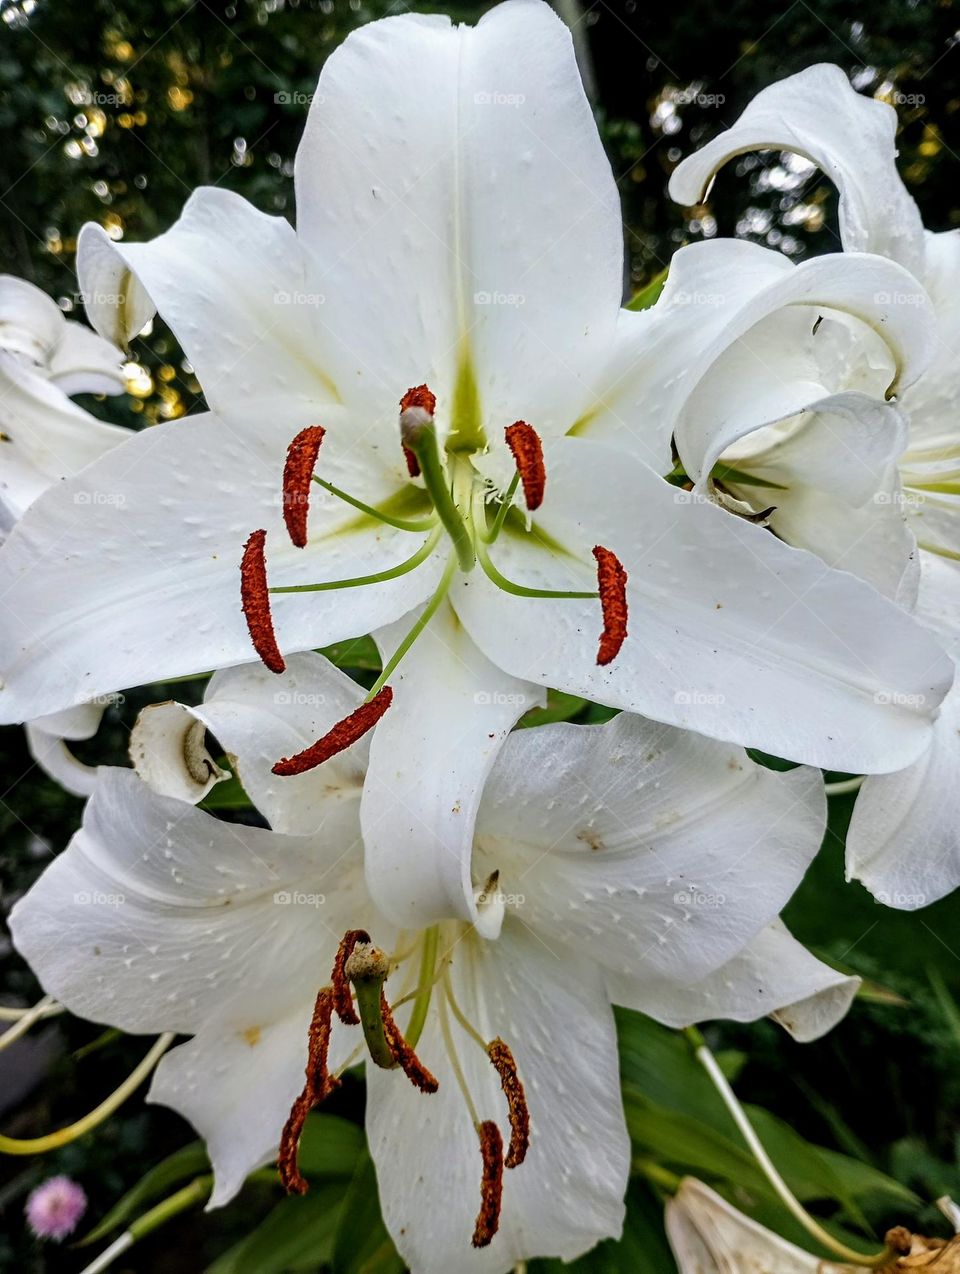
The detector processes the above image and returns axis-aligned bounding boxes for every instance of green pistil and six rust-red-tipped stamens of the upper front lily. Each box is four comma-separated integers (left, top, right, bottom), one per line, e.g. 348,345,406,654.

241,385,626,775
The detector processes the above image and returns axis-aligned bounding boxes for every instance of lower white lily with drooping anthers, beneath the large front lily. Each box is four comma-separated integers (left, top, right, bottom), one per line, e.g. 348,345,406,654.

10,654,856,1274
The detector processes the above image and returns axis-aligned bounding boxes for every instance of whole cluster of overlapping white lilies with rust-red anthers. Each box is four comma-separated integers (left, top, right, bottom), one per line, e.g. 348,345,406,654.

0,0,960,1274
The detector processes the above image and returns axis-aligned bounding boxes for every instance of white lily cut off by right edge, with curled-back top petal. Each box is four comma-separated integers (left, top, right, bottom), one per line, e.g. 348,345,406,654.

670,65,960,910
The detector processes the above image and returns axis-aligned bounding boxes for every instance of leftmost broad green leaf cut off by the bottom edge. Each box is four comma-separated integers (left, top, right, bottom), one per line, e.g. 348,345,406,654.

206,1181,345,1274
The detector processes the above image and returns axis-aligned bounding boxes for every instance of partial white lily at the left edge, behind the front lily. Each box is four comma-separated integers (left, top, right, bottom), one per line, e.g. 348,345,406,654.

0,274,130,531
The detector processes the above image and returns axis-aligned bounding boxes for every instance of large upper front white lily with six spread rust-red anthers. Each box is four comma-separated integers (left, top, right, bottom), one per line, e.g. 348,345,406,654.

0,0,952,925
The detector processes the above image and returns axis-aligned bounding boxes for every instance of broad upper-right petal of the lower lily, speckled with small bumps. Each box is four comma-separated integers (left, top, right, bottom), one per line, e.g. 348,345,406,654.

477,713,826,987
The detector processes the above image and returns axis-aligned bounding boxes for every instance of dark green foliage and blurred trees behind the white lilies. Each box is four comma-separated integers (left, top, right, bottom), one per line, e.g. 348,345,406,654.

0,0,960,1274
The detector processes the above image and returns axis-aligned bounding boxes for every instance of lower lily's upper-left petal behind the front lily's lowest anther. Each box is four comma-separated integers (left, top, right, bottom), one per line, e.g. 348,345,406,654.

194,651,369,836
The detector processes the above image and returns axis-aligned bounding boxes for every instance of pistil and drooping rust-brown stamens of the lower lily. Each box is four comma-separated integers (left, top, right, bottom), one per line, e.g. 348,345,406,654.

278,924,530,1247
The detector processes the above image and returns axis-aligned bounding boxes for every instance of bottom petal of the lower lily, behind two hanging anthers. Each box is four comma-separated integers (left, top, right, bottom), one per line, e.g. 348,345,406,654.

367,921,630,1274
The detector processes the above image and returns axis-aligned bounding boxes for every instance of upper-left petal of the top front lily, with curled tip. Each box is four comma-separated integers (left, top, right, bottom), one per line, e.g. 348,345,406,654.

78,186,341,437
